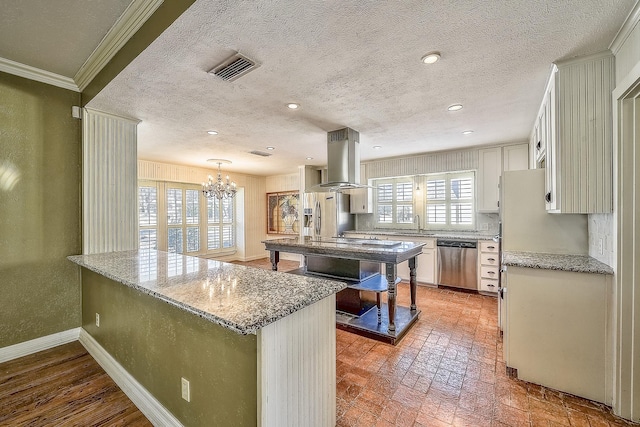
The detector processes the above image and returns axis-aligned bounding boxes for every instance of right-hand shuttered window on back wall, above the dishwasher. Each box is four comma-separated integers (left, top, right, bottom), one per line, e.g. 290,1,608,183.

425,172,475,229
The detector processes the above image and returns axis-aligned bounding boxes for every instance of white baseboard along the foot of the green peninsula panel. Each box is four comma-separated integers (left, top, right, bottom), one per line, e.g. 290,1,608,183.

80,329,182,427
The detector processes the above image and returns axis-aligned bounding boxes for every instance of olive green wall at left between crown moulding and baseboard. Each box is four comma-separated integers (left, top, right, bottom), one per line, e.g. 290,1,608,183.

0,72,81,348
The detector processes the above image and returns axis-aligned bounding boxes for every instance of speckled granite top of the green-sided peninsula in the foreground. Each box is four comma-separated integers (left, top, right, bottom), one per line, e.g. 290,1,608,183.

68,250,347,335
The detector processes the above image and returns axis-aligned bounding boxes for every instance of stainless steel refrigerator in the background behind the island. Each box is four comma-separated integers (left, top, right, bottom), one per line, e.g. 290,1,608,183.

303,192,355,237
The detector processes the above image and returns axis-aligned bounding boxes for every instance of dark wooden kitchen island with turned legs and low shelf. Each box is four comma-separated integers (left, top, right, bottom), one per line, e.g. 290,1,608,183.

263,237,424,344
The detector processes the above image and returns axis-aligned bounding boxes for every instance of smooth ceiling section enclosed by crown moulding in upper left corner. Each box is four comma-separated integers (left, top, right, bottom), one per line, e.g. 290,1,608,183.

0,0,132,78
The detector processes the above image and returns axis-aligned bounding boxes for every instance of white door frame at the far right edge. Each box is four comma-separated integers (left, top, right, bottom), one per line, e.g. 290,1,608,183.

613,58,640,421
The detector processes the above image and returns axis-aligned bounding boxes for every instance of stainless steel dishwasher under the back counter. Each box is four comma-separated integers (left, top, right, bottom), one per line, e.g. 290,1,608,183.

436,239,478,290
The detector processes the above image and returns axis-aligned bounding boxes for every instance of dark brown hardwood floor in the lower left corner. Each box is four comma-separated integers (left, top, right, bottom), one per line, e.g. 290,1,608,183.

0,341,151,427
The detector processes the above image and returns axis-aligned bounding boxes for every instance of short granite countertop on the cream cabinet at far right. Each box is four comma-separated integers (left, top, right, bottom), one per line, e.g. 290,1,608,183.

502,252,613,274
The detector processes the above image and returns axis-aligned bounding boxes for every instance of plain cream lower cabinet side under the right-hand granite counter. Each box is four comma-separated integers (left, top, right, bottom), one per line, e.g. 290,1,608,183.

503,266,613,405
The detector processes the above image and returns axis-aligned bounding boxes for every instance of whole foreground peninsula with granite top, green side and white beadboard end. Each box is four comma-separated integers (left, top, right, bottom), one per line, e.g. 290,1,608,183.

69,250,346,427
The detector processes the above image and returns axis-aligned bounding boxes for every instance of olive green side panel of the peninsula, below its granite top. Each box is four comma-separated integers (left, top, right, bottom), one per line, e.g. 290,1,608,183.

82,268,258,427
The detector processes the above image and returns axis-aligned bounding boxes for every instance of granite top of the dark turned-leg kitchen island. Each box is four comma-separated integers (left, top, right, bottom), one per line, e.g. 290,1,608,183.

262,237,425,263
